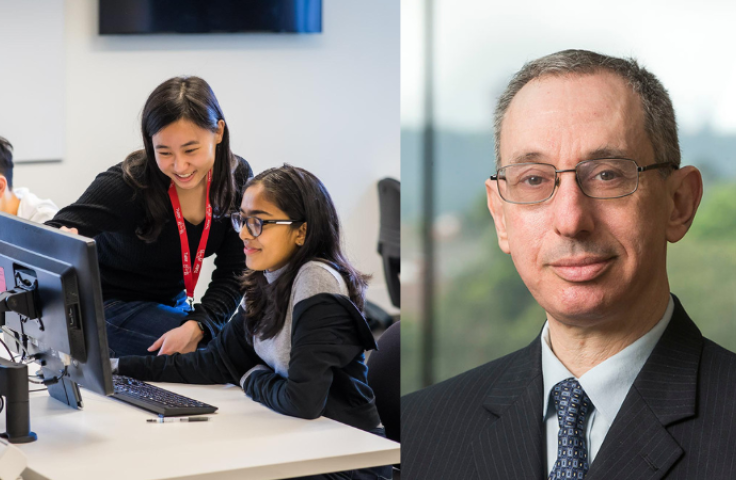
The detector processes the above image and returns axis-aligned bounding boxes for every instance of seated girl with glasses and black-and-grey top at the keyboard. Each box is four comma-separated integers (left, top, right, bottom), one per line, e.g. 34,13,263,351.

113,165,391,479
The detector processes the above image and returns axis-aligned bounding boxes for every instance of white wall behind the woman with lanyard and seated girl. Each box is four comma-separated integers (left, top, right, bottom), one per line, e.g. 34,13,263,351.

11,0,400,311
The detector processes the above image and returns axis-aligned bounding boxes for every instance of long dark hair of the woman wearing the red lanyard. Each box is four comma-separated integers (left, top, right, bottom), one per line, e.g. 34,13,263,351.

123,77,238,242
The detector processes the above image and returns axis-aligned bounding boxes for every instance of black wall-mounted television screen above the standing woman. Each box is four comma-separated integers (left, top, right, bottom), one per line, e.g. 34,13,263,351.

99,0,322,35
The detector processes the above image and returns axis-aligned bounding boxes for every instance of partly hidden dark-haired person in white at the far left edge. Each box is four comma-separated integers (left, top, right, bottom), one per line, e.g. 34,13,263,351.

0,137,59,223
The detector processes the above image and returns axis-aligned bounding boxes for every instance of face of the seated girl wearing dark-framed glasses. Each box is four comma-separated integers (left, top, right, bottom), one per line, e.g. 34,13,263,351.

240,183,307,271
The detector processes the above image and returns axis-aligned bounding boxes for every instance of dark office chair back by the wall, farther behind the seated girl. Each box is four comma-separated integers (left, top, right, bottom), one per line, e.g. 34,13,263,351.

378,178,401,308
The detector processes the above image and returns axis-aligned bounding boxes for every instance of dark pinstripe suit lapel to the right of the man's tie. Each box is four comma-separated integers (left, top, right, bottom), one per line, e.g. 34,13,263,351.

585,297,703,480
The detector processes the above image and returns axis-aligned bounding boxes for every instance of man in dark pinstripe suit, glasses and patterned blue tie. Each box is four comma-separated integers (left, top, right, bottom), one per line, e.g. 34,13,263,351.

402,50,736,480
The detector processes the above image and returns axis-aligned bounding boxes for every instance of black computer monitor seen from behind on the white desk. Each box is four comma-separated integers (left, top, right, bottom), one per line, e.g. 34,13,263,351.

0,212,113,441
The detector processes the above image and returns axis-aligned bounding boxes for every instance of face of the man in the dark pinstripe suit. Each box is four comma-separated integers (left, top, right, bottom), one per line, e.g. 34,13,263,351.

486,72,684,325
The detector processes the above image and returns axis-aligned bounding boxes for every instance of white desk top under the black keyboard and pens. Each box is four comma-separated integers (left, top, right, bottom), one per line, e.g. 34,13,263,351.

5,384,399,480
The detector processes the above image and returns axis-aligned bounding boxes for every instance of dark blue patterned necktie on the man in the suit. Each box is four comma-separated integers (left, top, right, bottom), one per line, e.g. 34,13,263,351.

549,378,594,480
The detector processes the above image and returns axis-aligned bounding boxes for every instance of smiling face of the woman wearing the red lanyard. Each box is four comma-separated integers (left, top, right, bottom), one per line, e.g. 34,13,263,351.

151,119,225,190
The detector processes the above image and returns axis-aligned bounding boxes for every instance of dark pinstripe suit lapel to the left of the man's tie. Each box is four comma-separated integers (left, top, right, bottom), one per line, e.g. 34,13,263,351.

472,337,544,480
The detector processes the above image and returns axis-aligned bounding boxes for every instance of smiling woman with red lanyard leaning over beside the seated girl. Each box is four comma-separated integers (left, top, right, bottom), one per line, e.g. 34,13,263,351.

47,77,253,356
